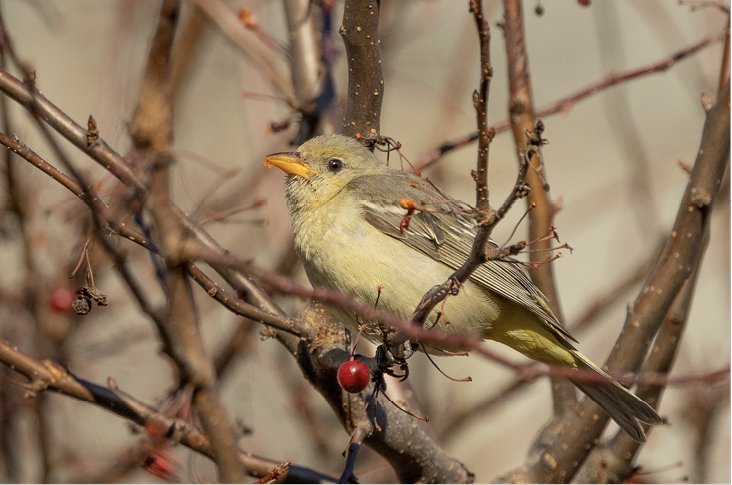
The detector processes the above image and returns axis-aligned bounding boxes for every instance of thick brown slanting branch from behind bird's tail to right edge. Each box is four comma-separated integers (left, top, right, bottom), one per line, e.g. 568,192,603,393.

513,80,730,481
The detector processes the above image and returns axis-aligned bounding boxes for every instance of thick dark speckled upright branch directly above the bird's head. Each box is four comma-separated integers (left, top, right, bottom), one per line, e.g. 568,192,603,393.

339,0,384,137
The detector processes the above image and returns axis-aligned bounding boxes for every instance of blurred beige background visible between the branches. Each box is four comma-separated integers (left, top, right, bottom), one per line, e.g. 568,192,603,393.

0,0,730,483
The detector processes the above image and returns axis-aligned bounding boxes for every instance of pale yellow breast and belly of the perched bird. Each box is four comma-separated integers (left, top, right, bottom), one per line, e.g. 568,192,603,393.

294,197,499,335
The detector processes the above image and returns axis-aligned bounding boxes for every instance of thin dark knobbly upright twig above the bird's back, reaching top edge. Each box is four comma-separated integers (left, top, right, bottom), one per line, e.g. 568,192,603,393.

470,0,494,211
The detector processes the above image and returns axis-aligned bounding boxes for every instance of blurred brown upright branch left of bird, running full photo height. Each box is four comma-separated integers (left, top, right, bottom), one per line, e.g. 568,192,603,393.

130,0,243,483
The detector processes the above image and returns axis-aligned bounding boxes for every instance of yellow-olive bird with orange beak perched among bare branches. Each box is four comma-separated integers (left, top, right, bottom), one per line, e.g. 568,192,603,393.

263,134,663,442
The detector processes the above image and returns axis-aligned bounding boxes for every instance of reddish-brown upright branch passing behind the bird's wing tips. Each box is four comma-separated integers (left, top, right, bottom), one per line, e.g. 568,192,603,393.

503,0,577,416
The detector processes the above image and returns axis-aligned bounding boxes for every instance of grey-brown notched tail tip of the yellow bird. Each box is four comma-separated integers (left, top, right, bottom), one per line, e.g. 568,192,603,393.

570,350,663,442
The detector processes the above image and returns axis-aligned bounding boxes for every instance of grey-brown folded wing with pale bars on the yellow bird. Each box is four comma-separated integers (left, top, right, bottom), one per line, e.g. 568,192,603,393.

349,172,577,342
